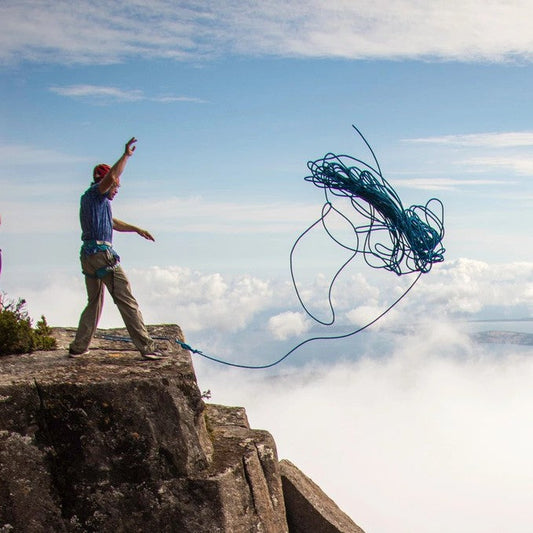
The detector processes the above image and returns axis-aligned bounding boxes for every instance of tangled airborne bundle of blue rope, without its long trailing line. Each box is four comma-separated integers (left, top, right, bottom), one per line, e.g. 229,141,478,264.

305,126,445,275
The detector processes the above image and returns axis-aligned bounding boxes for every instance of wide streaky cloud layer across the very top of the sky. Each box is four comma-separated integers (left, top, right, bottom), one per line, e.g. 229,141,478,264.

0,0,533,63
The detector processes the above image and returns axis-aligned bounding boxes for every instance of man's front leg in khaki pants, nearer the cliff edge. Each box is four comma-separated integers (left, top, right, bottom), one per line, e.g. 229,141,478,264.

102,265,155,355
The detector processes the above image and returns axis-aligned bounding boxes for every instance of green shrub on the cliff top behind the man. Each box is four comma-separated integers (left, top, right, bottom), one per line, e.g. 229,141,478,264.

0,295,56,355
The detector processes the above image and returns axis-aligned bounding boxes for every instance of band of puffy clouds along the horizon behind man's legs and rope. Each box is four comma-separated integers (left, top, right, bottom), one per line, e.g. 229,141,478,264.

14,259,533,343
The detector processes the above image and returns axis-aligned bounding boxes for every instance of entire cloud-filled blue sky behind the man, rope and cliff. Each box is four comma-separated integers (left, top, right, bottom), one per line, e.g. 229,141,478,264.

0,0,533,533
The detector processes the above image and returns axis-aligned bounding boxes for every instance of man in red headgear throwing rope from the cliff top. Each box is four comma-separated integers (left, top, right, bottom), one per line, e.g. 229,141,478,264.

69,137,162,359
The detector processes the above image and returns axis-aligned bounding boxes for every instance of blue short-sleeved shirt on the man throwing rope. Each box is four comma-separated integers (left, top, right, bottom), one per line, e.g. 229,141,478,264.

80,183,113,243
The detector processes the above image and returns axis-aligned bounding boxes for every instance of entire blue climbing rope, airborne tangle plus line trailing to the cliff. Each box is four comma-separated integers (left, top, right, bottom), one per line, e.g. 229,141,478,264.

96,126,445,370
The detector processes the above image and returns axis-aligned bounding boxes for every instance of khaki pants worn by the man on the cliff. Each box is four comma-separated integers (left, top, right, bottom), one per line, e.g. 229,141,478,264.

70,251,155,354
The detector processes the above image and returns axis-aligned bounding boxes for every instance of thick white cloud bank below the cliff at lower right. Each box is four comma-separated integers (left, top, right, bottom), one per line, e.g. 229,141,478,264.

196,336,533,533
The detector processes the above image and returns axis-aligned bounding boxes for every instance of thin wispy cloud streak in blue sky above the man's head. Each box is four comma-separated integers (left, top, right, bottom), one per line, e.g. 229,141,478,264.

50,85,205,103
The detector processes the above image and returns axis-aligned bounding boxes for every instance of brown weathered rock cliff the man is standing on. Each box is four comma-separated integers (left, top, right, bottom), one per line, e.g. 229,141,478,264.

0,326,362,533
